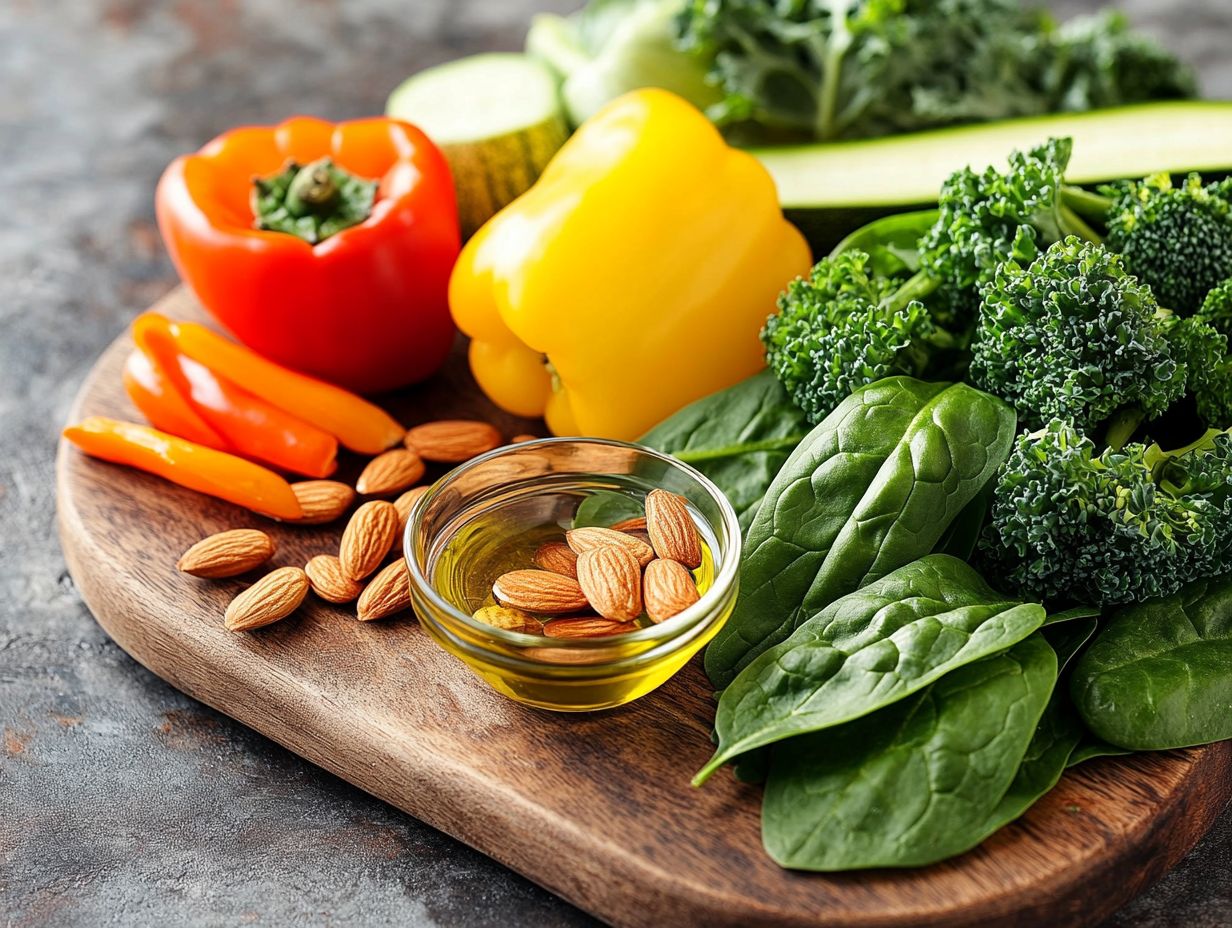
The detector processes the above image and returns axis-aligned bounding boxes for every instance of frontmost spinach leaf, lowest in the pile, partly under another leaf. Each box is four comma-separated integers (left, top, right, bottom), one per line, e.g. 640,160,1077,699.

761,635,1057,870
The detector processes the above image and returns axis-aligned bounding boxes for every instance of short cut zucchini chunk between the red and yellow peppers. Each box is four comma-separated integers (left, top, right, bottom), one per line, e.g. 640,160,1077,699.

386,53,569,235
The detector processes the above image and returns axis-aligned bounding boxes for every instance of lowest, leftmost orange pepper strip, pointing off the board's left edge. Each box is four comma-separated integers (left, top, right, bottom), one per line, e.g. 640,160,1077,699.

64,415,303,520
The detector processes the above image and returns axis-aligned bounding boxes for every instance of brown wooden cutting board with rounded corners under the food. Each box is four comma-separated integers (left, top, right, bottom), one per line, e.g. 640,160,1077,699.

58,285,1232,928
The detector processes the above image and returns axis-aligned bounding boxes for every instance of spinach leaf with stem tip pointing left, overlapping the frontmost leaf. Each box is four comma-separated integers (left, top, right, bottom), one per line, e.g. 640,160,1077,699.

694,555,1045,784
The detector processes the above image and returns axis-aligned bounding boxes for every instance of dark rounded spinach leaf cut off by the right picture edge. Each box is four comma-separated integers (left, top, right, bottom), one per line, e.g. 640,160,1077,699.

1071,576,1232,751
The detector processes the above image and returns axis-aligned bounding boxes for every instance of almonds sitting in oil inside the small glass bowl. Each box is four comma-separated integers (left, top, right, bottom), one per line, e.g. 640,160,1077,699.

474,489,702,638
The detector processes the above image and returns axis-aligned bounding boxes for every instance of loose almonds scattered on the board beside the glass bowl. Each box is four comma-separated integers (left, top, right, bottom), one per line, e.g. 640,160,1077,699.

176,419,534,631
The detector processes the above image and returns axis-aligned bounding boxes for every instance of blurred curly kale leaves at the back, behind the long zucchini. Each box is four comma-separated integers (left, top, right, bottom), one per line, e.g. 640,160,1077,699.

679,0,1194,139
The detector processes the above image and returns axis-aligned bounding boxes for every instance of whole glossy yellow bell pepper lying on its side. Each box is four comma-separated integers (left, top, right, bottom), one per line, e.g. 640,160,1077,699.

450,90,811,439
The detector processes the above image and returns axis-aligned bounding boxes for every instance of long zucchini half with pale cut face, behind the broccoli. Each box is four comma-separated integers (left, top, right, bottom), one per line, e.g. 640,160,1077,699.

753,100,1232,254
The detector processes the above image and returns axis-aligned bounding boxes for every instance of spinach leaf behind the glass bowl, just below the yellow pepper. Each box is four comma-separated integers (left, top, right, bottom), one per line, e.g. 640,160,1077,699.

574,371,811,529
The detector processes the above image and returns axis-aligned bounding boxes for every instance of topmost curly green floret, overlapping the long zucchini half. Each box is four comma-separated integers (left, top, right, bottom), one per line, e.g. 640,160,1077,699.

919,138,1099,322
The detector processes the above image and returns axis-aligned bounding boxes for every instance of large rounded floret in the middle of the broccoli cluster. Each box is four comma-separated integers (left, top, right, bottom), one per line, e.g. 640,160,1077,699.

971,237,1188,444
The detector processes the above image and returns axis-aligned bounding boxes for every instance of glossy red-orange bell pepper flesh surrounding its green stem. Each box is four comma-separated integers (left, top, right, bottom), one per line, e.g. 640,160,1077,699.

155,117,460,393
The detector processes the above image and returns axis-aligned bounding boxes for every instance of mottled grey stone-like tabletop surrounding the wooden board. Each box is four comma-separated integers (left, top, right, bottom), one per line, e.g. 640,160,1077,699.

0,0,1232,928
